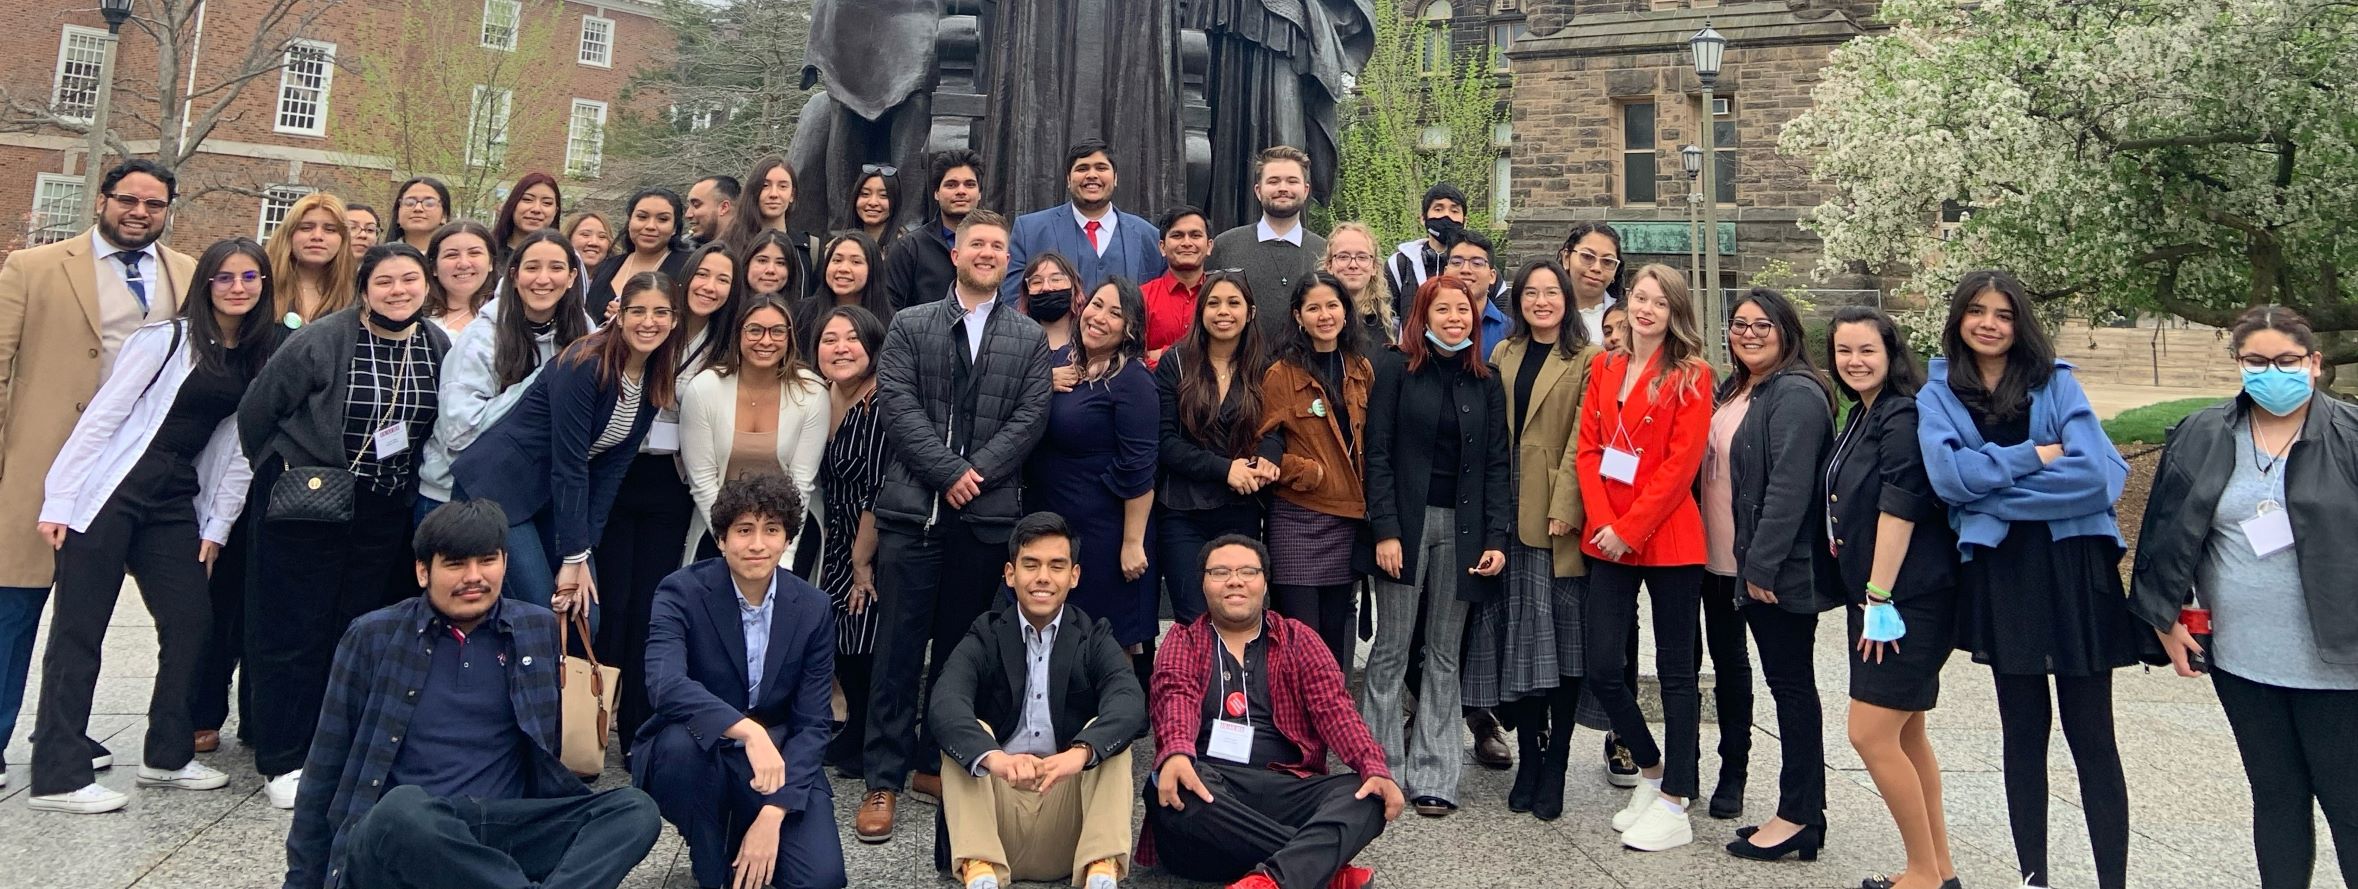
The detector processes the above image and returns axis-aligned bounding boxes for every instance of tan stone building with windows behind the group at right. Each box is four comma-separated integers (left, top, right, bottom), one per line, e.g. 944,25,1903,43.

1490,0,1882,290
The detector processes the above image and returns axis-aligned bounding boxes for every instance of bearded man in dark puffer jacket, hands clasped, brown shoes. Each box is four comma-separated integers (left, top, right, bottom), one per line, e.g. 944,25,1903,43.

856,210,1051,842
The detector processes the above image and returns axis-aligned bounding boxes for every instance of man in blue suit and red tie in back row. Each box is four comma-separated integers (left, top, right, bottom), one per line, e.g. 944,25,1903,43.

1000,139,1162,301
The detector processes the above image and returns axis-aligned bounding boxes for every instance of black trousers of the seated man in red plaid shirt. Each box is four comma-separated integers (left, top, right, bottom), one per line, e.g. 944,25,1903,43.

1144,759,1384,889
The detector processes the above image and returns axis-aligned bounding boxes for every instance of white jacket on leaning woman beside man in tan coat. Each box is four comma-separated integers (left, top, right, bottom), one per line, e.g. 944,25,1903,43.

40,318,255,545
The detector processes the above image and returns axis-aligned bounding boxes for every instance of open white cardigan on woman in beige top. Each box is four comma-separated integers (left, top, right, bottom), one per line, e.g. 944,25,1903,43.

679,370,832,566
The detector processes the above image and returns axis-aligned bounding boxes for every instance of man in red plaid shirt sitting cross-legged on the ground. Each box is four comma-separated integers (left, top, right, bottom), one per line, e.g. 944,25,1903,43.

1139,535,1403,889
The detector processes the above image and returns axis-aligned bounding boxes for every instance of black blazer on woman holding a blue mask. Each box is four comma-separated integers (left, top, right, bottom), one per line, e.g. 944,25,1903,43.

1818,391,1957,604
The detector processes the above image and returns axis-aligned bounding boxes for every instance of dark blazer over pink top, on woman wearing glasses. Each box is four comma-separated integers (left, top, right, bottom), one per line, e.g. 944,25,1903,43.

1728,366,1842,613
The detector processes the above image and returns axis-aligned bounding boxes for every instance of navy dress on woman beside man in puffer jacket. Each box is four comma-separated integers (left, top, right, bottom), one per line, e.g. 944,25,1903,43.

1023,349,1162,646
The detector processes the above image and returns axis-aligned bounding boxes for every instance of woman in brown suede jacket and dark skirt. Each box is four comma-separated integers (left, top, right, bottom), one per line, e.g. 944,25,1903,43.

1262,271,1375,677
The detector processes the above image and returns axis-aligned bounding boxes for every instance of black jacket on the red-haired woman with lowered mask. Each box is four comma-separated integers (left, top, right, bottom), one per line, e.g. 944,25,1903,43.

1363,354,1514,601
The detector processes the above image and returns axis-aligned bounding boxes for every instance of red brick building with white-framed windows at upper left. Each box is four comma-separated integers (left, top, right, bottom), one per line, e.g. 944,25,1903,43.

0,0,670,252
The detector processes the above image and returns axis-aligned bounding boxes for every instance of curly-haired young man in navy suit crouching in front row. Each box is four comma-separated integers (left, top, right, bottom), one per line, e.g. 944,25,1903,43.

630,476,849,889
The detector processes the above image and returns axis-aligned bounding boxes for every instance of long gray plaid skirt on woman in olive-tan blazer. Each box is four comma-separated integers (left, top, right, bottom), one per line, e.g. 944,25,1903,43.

1460,542,1589,707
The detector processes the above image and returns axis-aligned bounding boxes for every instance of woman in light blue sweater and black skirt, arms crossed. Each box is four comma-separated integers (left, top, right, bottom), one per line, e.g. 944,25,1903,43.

1917,271,2153,889
